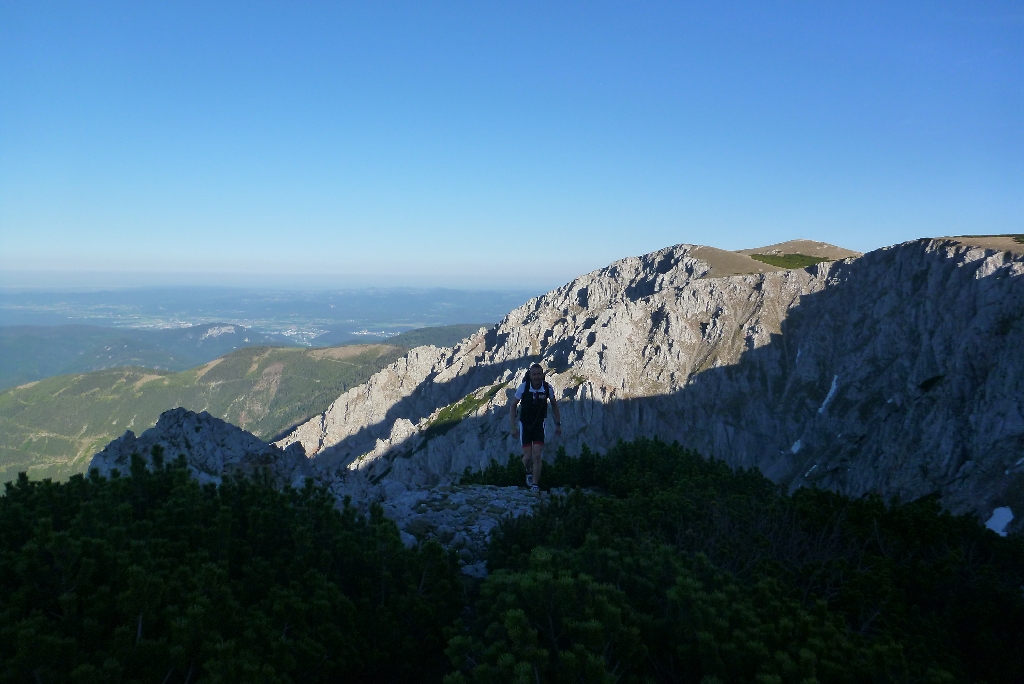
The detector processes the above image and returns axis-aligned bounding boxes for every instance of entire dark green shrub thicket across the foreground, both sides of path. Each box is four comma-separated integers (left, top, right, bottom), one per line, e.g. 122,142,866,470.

0,440,1024,684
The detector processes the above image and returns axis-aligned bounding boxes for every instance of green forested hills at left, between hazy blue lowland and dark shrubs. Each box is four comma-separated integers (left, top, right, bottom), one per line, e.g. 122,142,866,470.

0,324,481,482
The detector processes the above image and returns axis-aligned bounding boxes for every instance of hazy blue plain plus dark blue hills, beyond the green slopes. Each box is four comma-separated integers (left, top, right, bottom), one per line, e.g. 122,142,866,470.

0,288,540,389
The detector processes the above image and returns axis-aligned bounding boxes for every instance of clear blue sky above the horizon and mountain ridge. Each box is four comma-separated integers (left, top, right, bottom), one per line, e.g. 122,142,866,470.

0,0,1024,287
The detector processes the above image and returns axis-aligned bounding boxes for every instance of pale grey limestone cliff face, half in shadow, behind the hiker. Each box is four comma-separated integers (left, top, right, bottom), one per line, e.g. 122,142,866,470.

278,240,1024,525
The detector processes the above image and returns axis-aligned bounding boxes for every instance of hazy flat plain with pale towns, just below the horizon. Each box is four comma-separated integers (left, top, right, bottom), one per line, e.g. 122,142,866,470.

0,287,542,339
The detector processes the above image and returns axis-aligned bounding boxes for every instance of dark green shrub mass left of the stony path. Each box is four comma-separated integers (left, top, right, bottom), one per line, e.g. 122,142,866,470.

0,458,462,683
